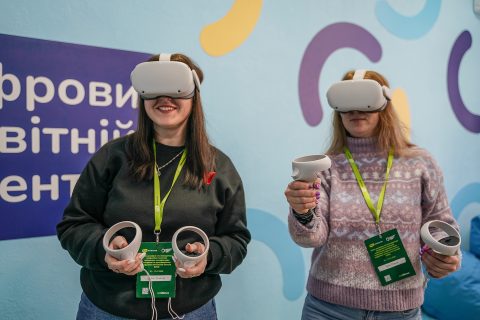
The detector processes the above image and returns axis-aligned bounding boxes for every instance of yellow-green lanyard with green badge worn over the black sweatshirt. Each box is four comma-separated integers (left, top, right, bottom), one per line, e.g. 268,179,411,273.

136,140,187,298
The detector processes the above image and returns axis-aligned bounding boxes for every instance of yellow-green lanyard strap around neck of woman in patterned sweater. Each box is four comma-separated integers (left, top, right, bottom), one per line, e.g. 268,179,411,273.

343,147,393,234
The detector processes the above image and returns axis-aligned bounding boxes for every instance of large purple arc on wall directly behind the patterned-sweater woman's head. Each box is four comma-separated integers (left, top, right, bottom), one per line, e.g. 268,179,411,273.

298,23,382,127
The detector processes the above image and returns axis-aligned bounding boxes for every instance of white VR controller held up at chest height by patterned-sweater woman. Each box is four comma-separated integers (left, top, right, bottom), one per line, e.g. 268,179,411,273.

292,154,332,182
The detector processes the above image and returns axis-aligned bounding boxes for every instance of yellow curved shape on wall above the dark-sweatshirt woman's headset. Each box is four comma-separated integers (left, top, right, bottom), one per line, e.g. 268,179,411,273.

200,0,263,56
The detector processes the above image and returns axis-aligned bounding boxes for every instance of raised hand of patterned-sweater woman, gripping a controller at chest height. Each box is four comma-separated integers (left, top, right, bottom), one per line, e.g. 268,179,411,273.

285,179,320,214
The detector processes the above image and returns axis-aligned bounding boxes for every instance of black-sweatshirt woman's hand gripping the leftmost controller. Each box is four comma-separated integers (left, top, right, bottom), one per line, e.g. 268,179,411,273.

105,236,145,276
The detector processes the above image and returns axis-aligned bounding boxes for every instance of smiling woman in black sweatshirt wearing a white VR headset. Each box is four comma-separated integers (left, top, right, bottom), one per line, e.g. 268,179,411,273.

57,54,250,320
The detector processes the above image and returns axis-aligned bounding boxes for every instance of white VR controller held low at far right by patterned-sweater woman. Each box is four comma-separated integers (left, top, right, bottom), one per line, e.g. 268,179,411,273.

420,220,462,256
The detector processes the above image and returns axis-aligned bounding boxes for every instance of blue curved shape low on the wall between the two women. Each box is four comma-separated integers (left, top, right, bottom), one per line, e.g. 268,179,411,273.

247,208,305,301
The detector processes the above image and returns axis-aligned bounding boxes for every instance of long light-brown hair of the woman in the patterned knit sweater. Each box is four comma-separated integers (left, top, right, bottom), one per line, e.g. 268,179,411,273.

327,70,414,155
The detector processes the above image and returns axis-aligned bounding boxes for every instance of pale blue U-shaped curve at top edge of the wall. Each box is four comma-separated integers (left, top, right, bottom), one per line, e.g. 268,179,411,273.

375,0,442,39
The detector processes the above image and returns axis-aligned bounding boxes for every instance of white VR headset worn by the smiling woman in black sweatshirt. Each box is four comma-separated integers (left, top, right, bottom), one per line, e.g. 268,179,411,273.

130,53,200,100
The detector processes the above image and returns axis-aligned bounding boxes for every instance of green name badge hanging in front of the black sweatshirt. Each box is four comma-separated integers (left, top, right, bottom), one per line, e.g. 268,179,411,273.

136,242,176,298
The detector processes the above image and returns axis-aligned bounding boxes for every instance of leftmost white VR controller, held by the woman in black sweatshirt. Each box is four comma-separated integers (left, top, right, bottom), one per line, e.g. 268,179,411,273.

103,221,142,260
